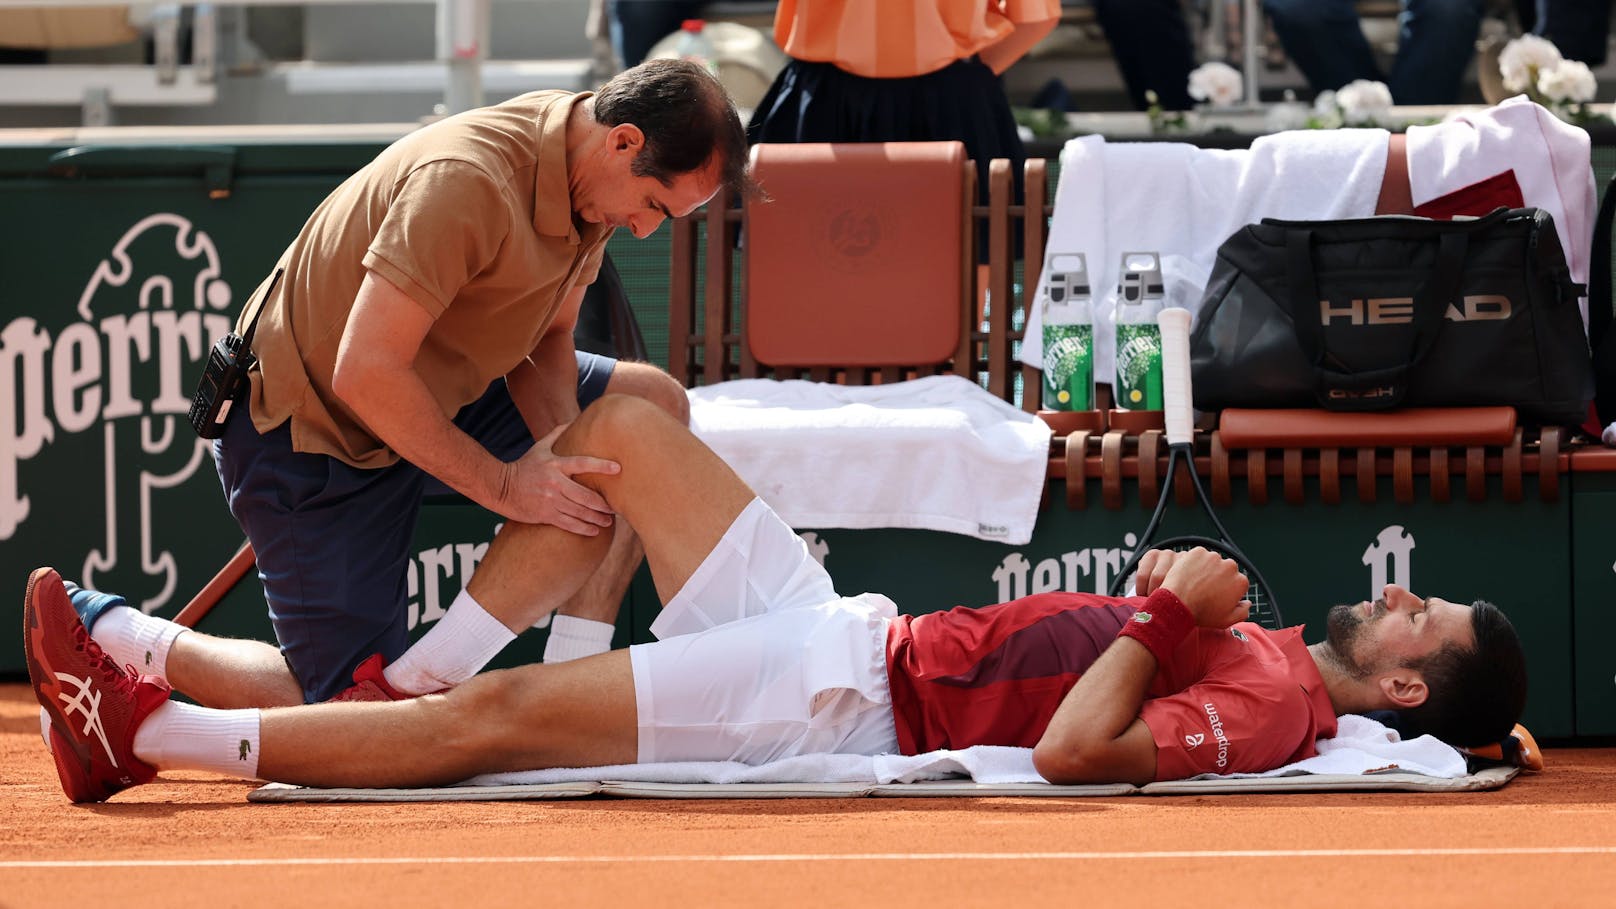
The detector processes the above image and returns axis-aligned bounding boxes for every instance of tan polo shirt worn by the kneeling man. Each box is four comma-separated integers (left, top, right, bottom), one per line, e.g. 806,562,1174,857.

238,92,611,467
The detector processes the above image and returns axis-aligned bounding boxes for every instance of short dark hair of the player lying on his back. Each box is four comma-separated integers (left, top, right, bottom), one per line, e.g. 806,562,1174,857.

1399,600,1526,747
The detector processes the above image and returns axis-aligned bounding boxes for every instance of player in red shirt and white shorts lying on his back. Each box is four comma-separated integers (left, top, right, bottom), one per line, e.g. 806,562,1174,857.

24,396,1526,801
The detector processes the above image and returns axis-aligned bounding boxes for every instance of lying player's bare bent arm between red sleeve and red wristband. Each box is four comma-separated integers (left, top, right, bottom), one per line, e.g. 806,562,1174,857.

1033,637,1157,784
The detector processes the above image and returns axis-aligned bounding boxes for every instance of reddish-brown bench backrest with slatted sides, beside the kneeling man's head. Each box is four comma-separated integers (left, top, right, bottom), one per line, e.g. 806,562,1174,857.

667,142,1049,399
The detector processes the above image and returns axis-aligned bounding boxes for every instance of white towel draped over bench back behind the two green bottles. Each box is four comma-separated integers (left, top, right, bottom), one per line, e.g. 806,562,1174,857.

1020,123,1388,382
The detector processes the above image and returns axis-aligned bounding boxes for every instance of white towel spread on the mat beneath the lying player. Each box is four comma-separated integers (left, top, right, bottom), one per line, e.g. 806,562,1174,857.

462,715,1466,786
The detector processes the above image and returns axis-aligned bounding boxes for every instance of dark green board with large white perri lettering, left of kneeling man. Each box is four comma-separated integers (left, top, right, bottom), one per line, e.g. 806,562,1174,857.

0,139,377,670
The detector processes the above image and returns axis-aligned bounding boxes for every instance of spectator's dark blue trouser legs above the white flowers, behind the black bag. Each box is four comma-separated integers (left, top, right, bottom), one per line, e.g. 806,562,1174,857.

1262,0,1485,104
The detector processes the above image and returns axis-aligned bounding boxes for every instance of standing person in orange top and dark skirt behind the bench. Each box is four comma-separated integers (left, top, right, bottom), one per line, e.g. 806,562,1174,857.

747,0,1060,242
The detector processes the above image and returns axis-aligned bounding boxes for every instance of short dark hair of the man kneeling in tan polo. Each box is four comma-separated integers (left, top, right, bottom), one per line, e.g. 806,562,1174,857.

595,60,756,197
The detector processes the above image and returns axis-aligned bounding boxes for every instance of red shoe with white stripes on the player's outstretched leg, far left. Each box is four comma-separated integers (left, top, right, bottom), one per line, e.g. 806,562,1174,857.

23,568,170,802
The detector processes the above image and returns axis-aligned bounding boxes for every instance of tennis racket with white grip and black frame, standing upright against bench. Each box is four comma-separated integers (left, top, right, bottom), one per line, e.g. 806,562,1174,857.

1110,307,1285,629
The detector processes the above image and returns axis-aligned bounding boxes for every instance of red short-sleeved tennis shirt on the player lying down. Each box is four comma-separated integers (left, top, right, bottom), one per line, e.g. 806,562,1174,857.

887,594,1335,780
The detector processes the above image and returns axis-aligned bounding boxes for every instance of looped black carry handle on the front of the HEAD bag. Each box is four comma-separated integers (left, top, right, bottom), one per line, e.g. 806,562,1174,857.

1285,222,1474,411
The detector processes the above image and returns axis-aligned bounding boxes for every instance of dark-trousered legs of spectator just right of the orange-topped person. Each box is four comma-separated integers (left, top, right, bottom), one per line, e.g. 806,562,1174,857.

1094,0,1196,110
